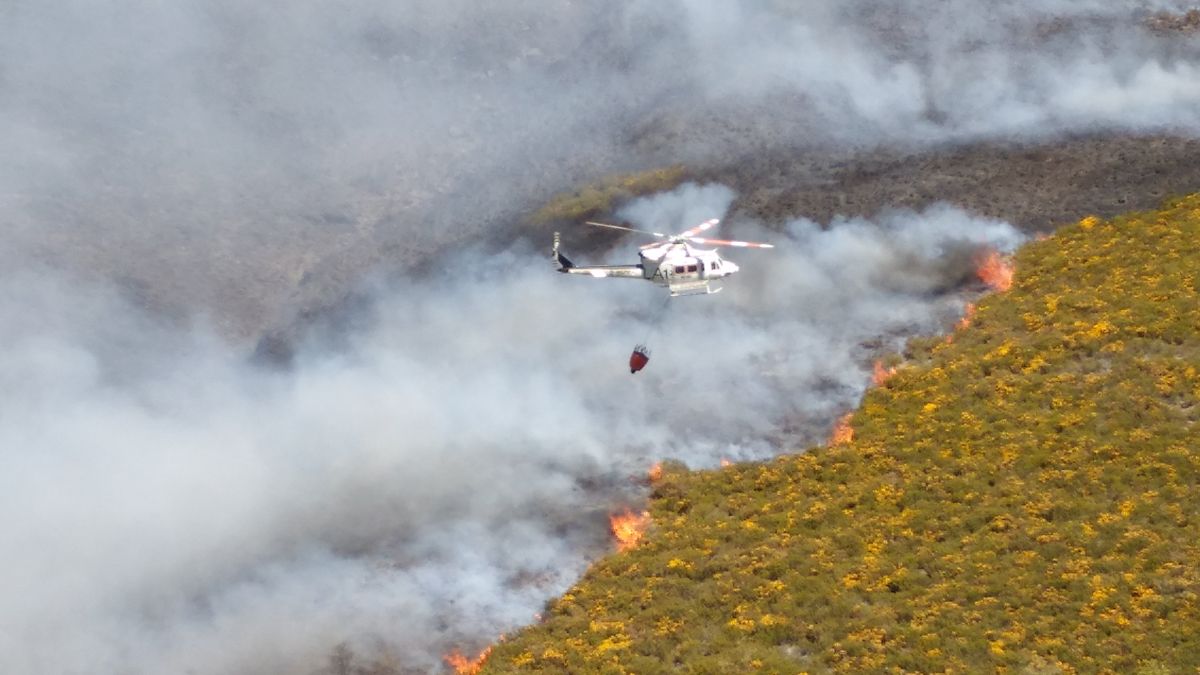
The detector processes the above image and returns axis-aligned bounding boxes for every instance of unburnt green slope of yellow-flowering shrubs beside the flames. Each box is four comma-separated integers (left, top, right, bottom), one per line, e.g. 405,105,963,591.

485,196,1200,673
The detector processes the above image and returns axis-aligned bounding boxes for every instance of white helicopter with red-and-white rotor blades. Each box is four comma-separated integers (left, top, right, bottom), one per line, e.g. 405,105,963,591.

552,219,775,298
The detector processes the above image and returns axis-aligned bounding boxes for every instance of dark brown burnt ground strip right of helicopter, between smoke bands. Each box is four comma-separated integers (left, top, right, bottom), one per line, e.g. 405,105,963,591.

700,136,1200,232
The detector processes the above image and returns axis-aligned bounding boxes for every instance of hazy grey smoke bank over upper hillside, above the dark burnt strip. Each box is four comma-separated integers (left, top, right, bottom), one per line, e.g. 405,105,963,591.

0,0,1200,342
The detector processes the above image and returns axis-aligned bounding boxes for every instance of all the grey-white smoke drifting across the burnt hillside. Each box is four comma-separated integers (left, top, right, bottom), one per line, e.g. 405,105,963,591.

0,0,1200,674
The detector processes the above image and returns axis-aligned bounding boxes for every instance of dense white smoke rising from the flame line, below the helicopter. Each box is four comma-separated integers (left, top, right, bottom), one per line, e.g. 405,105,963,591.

0,181,1019,673
